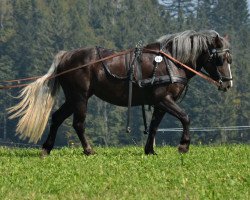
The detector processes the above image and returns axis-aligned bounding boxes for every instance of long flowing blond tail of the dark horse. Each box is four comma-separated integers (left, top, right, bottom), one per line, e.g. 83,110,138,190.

8,51,66,143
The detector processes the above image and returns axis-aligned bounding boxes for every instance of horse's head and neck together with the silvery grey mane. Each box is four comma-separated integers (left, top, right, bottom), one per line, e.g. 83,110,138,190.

157,30,233,91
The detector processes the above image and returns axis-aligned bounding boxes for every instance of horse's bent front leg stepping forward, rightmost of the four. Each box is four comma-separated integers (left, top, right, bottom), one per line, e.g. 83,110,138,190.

160,95,190,153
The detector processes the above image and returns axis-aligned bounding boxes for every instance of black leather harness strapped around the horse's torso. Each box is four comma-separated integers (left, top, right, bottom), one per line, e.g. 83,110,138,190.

96,44,188,134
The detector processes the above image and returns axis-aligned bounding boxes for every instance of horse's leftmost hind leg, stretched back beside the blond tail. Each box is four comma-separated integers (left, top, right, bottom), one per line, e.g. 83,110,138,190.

41,102,73,156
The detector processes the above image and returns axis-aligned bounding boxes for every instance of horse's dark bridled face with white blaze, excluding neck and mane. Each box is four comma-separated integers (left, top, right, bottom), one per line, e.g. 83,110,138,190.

203,35,233,91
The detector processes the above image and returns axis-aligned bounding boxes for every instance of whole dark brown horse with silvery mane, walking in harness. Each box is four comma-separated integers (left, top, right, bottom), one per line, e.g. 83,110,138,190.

9,30,233,156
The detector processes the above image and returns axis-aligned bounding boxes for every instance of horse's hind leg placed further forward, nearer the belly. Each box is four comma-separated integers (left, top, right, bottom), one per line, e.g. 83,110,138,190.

73,100,94,155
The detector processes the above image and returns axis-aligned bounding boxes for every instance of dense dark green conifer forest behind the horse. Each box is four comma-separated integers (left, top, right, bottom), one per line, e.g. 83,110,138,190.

0,0,250,145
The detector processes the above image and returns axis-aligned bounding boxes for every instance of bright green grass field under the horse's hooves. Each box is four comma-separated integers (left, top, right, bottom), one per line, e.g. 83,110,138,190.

0,145,250,200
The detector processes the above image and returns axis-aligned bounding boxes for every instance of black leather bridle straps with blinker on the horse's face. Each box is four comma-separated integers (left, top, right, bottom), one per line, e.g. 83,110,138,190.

208,49,233,84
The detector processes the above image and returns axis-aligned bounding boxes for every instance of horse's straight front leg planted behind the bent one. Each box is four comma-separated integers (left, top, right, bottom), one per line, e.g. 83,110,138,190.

145,106,165,155
